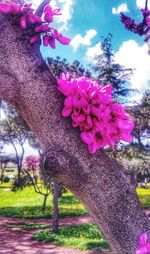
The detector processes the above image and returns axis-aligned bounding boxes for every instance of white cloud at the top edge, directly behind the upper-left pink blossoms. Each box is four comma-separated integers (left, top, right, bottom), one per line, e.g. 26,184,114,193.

32,0,74,31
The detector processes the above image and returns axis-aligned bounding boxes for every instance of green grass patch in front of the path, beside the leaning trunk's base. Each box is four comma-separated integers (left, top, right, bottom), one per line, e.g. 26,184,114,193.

32,224,109,250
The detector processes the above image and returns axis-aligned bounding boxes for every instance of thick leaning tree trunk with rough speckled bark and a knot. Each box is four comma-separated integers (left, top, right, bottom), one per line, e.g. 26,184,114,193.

0,10,150,254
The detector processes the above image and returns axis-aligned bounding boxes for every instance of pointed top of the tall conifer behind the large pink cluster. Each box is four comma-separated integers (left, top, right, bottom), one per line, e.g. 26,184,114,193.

92,34,133,102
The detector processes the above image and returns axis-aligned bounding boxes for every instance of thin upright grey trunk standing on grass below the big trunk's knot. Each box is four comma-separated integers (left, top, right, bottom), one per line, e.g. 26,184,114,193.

52,180,60,233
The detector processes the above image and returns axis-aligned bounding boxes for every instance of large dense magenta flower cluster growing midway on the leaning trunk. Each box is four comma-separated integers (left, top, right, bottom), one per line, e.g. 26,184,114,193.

58,73,134,153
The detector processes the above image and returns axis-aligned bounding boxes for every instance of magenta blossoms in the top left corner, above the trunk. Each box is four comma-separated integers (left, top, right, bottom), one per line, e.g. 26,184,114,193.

0,1,70,48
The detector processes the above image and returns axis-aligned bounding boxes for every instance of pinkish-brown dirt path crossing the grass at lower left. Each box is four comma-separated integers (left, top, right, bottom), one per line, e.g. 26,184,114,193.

0,216,110,254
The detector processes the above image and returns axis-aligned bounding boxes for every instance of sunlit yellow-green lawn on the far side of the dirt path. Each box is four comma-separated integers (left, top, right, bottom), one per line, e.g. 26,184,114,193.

0,184,150,218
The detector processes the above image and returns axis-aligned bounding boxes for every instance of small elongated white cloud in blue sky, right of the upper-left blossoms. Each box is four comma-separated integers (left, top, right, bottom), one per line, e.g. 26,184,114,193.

70,29,97,51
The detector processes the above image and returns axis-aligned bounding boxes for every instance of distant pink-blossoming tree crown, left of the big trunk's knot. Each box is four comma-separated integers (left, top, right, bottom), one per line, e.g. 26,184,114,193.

24,155,40,171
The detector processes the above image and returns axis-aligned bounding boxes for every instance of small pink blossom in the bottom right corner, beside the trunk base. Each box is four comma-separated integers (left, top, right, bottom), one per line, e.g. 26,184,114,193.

136,233,150,254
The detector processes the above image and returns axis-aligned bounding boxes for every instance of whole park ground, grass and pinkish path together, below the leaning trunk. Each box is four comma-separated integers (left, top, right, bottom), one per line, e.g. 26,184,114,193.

0,184,150,254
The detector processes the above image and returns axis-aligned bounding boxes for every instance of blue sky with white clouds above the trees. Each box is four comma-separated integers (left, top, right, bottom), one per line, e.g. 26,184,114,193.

31,0,150,92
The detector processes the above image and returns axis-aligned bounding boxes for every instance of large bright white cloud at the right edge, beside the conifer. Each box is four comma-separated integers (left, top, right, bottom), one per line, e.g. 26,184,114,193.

115,40,150,92
